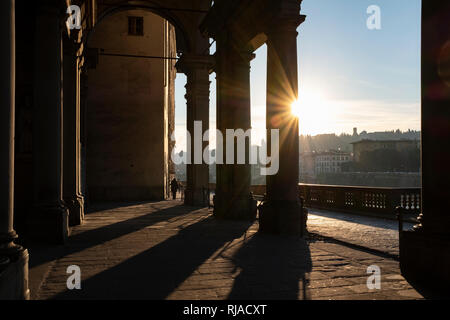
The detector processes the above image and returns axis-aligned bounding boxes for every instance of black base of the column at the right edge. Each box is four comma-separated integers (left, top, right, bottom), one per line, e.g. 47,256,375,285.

400,231,450,296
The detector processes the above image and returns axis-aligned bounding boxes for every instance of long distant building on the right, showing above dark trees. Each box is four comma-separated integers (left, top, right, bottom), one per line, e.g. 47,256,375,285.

352,139,420,162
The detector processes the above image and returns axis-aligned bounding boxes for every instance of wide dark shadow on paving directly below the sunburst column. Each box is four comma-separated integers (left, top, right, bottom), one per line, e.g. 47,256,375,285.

228,234,312,300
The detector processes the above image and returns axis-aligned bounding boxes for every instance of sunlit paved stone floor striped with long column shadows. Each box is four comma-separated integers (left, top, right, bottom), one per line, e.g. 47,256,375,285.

30,201,422,300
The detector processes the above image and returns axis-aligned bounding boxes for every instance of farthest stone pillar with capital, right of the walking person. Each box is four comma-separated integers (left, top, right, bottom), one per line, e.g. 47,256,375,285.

176,54,211,206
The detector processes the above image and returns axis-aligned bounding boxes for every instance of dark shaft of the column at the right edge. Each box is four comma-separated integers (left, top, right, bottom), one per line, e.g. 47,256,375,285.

421,3,450,235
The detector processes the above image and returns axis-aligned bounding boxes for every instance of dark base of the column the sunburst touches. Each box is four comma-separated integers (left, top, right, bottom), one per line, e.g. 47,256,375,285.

259,200,307,237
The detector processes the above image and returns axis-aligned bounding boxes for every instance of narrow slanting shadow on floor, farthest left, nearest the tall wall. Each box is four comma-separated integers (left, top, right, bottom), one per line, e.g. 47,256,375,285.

28,205,198,268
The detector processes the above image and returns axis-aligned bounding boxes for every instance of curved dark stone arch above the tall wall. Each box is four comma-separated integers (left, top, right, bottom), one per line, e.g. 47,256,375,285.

85,1,192,52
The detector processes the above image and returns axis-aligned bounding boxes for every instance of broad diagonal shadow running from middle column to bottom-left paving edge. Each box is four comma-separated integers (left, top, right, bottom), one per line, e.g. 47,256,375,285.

50,217,250,300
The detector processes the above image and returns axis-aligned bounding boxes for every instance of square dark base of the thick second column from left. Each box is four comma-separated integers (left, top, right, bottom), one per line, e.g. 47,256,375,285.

27,205,70,244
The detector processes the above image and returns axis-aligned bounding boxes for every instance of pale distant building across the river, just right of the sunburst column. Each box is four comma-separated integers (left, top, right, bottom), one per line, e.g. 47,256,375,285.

300,150,352,176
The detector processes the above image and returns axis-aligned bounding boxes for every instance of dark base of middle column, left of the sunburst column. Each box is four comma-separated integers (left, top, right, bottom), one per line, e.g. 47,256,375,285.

214,194,257,221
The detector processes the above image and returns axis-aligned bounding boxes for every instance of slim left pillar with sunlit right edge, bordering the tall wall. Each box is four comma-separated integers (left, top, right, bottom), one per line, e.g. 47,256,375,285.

63,39,84,226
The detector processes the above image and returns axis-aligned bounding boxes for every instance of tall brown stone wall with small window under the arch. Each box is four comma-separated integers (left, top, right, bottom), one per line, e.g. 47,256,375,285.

86,10,175,201
